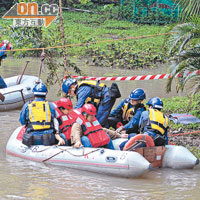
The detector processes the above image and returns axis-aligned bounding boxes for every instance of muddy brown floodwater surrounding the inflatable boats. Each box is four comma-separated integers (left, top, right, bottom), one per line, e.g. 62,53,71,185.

0,58,200,200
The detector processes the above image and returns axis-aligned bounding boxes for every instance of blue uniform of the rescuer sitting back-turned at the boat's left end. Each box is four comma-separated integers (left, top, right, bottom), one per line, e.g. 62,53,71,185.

19,97,55,145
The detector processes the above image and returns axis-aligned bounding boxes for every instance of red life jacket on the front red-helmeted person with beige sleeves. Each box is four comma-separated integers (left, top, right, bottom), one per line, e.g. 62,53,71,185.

70,109,110,147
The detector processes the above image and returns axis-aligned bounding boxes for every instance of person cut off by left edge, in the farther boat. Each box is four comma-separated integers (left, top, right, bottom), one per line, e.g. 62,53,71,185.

0,37,12,89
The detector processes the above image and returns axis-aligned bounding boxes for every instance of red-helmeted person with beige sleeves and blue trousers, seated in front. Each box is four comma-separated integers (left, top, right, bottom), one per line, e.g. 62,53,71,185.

71,104,127,149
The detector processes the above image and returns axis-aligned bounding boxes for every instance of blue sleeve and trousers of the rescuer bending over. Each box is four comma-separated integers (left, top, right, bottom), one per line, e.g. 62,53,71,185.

75,85,115,125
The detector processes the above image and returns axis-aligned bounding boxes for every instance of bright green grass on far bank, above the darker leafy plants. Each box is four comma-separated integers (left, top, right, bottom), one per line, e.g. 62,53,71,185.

60,12,169,55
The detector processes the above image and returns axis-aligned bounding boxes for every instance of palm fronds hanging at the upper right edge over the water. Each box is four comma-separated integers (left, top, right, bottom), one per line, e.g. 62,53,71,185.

166,0,200,94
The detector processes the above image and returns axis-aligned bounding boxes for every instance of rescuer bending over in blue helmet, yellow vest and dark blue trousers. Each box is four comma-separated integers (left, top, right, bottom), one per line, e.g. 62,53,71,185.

62,78,121,125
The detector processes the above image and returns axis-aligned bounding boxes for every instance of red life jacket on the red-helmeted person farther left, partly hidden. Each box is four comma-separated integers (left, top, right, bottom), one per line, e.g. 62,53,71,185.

55,107,74,140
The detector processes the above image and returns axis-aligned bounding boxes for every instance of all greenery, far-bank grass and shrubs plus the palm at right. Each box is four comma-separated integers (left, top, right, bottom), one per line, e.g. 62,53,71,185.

0,0,200,157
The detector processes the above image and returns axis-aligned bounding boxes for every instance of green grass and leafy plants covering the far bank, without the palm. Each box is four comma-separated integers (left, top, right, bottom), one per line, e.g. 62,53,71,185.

0,12,172,69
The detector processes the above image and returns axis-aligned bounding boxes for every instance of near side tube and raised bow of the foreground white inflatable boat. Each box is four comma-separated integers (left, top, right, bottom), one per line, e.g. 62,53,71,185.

6,127,151,177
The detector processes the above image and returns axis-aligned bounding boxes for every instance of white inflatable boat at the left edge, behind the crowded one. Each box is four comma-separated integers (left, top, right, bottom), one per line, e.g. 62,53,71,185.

0,75,38,111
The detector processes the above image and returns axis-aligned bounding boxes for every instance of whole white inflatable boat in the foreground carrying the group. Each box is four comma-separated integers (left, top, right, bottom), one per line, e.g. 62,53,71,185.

6,126,199,178
